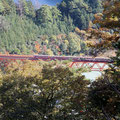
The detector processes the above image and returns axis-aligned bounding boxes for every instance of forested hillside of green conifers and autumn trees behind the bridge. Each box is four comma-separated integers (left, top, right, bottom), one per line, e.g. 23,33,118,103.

0,0,102,55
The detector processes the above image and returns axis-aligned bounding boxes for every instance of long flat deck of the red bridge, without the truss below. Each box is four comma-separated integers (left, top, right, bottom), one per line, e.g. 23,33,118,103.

0,54,113,63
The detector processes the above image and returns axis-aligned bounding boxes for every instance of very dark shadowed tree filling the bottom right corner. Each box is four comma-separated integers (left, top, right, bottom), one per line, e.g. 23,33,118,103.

88,73,120,120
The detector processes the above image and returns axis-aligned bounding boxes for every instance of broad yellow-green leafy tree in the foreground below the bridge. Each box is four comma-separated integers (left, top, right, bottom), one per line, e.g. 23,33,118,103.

0,62,89,120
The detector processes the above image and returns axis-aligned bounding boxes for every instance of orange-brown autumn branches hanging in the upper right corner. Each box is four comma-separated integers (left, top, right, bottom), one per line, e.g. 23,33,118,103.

88,0,120,49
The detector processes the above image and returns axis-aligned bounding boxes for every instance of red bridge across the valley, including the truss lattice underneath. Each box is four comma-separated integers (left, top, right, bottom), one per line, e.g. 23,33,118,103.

0,54,113,71
